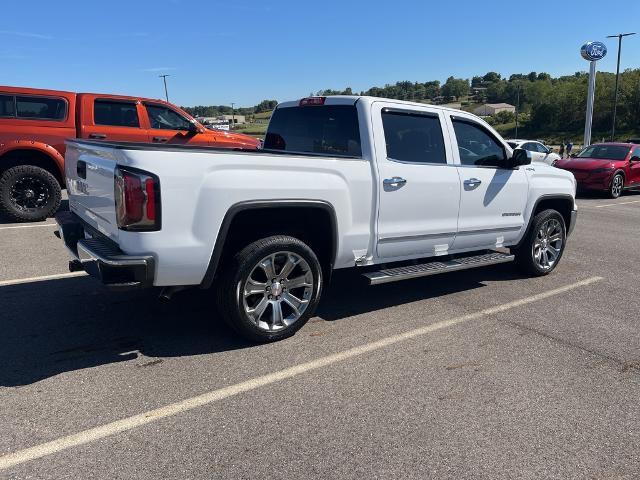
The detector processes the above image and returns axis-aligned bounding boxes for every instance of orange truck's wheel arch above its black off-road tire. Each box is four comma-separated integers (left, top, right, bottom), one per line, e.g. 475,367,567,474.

0,140,64,188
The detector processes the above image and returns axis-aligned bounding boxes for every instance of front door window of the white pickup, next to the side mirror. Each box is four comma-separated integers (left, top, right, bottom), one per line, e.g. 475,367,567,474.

452,119,506,167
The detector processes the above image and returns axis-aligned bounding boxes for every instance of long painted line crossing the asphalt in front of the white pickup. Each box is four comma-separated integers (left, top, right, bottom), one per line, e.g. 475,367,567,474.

0,277,602,470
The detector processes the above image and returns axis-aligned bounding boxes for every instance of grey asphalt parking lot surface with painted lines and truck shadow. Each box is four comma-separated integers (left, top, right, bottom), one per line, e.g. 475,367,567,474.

0,193,640,479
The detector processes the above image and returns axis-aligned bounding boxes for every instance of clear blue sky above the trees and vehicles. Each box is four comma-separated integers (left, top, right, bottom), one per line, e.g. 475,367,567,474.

0,0,640,106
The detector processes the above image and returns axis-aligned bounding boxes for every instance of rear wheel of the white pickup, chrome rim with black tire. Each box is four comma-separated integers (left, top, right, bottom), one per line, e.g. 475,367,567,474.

218,235,322,343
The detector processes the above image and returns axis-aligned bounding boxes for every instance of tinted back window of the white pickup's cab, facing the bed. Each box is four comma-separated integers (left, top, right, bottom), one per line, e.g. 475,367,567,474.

264,105,362,157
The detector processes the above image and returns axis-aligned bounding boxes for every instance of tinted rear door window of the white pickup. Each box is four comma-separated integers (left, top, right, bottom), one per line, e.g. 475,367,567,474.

382,111,447,164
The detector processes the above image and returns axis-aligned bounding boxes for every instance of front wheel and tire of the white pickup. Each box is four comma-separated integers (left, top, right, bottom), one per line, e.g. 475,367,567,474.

514,209,567,277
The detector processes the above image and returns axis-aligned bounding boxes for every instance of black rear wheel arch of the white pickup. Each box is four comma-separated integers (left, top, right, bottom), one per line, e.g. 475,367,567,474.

200,199,338,288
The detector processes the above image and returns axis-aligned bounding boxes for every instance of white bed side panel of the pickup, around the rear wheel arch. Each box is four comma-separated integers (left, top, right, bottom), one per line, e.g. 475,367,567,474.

87,149,372,286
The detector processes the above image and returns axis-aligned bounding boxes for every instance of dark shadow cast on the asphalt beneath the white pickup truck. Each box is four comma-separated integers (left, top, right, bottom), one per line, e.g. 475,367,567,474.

0,265,519,387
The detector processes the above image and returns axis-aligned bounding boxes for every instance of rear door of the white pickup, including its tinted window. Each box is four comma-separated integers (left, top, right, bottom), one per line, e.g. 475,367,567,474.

372,102,461,259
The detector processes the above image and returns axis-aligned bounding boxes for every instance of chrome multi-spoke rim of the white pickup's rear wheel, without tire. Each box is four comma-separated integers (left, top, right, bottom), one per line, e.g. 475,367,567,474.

242,251,314,331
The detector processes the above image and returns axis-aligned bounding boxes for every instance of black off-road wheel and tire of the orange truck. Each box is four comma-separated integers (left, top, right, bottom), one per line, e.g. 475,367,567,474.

0,165,62,222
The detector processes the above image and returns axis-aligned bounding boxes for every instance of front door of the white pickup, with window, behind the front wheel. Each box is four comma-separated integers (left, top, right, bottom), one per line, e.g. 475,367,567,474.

447,115,529,250
